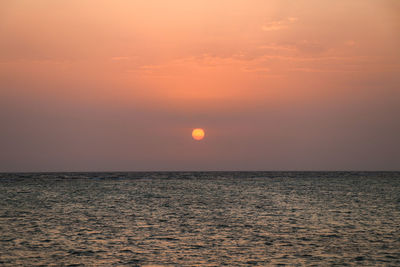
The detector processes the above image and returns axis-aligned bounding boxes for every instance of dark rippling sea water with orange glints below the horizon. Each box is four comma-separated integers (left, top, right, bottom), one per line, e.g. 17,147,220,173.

0,172,400,266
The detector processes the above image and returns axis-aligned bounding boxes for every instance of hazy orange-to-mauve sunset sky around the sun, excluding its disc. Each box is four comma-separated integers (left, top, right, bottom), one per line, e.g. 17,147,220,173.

0,0,400,172
